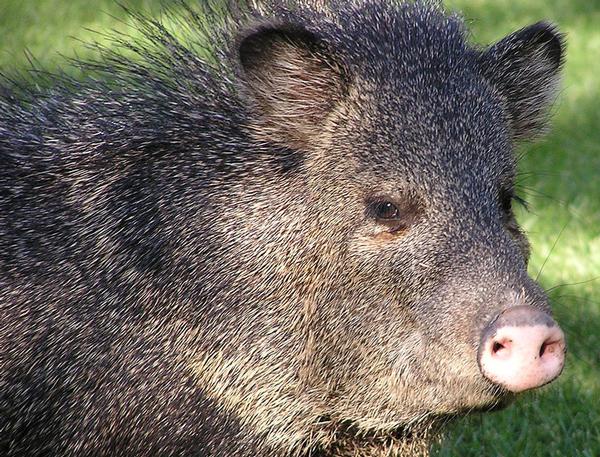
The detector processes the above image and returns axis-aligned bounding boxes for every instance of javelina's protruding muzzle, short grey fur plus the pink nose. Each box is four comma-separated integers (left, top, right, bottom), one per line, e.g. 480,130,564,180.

408,211,566,399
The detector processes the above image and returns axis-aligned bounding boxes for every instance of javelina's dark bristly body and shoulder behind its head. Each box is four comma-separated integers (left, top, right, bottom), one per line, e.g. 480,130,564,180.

0,13,252,456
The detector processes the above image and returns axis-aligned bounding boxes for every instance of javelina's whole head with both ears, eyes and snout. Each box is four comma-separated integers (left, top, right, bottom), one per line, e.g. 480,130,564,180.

200,2,564,455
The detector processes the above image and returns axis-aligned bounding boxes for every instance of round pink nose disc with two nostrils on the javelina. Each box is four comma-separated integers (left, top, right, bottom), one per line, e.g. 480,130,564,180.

479,306,566,392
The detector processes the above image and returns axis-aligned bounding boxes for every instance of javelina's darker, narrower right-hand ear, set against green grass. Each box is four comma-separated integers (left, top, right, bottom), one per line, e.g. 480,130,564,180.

481,22,564,139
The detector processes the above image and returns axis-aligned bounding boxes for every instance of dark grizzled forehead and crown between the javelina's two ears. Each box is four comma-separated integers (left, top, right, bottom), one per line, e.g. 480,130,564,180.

332,6,515,191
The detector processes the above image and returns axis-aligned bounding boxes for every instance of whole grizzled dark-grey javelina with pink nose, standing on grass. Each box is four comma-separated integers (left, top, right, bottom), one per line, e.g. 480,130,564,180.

0,0,565,457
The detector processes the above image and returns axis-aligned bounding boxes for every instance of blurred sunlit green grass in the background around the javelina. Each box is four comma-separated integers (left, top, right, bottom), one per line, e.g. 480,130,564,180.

0,0,600,457
